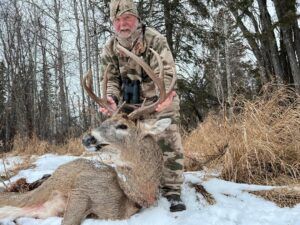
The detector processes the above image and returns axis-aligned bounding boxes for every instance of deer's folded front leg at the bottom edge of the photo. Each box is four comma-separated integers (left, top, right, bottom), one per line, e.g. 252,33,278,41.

62,190,90,225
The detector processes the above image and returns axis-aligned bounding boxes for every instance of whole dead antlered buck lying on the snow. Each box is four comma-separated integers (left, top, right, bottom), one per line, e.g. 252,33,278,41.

0,45,176,225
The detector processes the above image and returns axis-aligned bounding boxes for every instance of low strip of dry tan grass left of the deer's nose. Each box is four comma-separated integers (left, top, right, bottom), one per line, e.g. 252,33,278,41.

12,136,84,155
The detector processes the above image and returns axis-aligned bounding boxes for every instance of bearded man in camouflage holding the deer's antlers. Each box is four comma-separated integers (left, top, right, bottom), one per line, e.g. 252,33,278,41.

99,0,186,212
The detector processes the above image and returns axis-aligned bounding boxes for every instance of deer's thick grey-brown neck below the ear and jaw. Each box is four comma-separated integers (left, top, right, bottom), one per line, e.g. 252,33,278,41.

115,137,163,207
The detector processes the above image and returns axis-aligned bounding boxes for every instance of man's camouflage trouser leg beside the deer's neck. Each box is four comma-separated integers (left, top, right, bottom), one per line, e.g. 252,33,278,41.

158,124,183,197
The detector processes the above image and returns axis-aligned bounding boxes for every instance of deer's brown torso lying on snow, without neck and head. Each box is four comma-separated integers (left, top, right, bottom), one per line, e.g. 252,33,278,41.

0,159,138,224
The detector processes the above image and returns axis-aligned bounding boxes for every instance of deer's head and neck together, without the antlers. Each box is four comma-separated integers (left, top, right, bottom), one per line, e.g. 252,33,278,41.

82,114,171,207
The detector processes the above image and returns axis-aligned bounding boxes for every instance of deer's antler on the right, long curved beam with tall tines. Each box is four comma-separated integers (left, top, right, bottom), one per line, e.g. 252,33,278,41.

117,44,177,119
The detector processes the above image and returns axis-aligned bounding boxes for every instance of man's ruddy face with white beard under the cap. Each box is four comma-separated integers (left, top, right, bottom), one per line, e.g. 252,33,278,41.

113,13,139,38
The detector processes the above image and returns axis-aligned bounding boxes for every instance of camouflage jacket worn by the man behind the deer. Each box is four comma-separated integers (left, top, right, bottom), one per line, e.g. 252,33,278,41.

101,27,179,119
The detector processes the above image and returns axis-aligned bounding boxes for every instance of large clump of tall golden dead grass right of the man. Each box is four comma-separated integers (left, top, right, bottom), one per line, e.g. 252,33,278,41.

184,87,300,185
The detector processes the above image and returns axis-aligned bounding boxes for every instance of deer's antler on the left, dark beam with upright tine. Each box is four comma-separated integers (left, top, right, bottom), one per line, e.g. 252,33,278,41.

81,65,113,112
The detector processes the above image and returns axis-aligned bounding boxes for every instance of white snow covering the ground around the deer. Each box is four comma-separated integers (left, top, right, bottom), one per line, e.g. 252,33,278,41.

0,155,300,225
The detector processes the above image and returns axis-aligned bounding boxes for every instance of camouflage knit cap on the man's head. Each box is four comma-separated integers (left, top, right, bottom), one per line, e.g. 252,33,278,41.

110,0,140,22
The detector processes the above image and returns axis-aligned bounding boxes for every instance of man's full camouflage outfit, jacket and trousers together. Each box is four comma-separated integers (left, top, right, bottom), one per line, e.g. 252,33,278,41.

101,24,183,196
